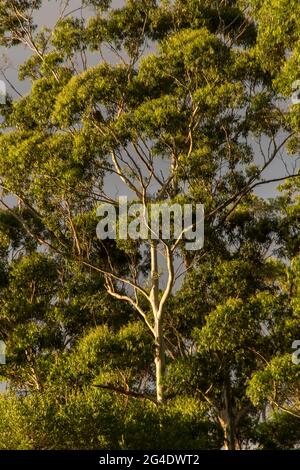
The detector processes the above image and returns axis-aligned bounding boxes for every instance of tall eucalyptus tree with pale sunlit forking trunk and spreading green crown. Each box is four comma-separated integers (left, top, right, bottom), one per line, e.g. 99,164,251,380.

0,0,296,402
